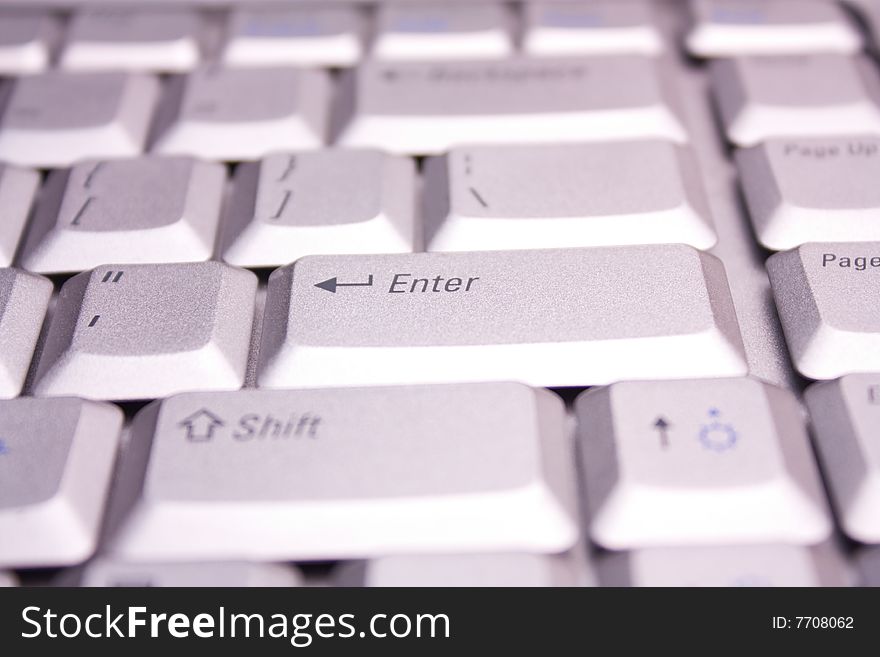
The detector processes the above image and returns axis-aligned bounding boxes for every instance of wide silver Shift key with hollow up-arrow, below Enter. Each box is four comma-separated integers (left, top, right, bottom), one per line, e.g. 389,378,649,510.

108,383,578,561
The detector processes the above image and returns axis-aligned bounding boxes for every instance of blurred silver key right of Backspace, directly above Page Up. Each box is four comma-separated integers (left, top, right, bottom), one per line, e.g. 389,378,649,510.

710,55,880,146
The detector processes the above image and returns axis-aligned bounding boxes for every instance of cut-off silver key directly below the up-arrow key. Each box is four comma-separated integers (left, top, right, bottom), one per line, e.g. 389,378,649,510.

596,544,848,587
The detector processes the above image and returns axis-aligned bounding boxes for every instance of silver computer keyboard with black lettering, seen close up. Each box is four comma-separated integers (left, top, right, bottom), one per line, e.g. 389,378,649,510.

0,0,880,587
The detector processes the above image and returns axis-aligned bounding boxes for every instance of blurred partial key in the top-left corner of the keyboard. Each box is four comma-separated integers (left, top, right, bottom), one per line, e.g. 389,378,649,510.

0,8,58,75
